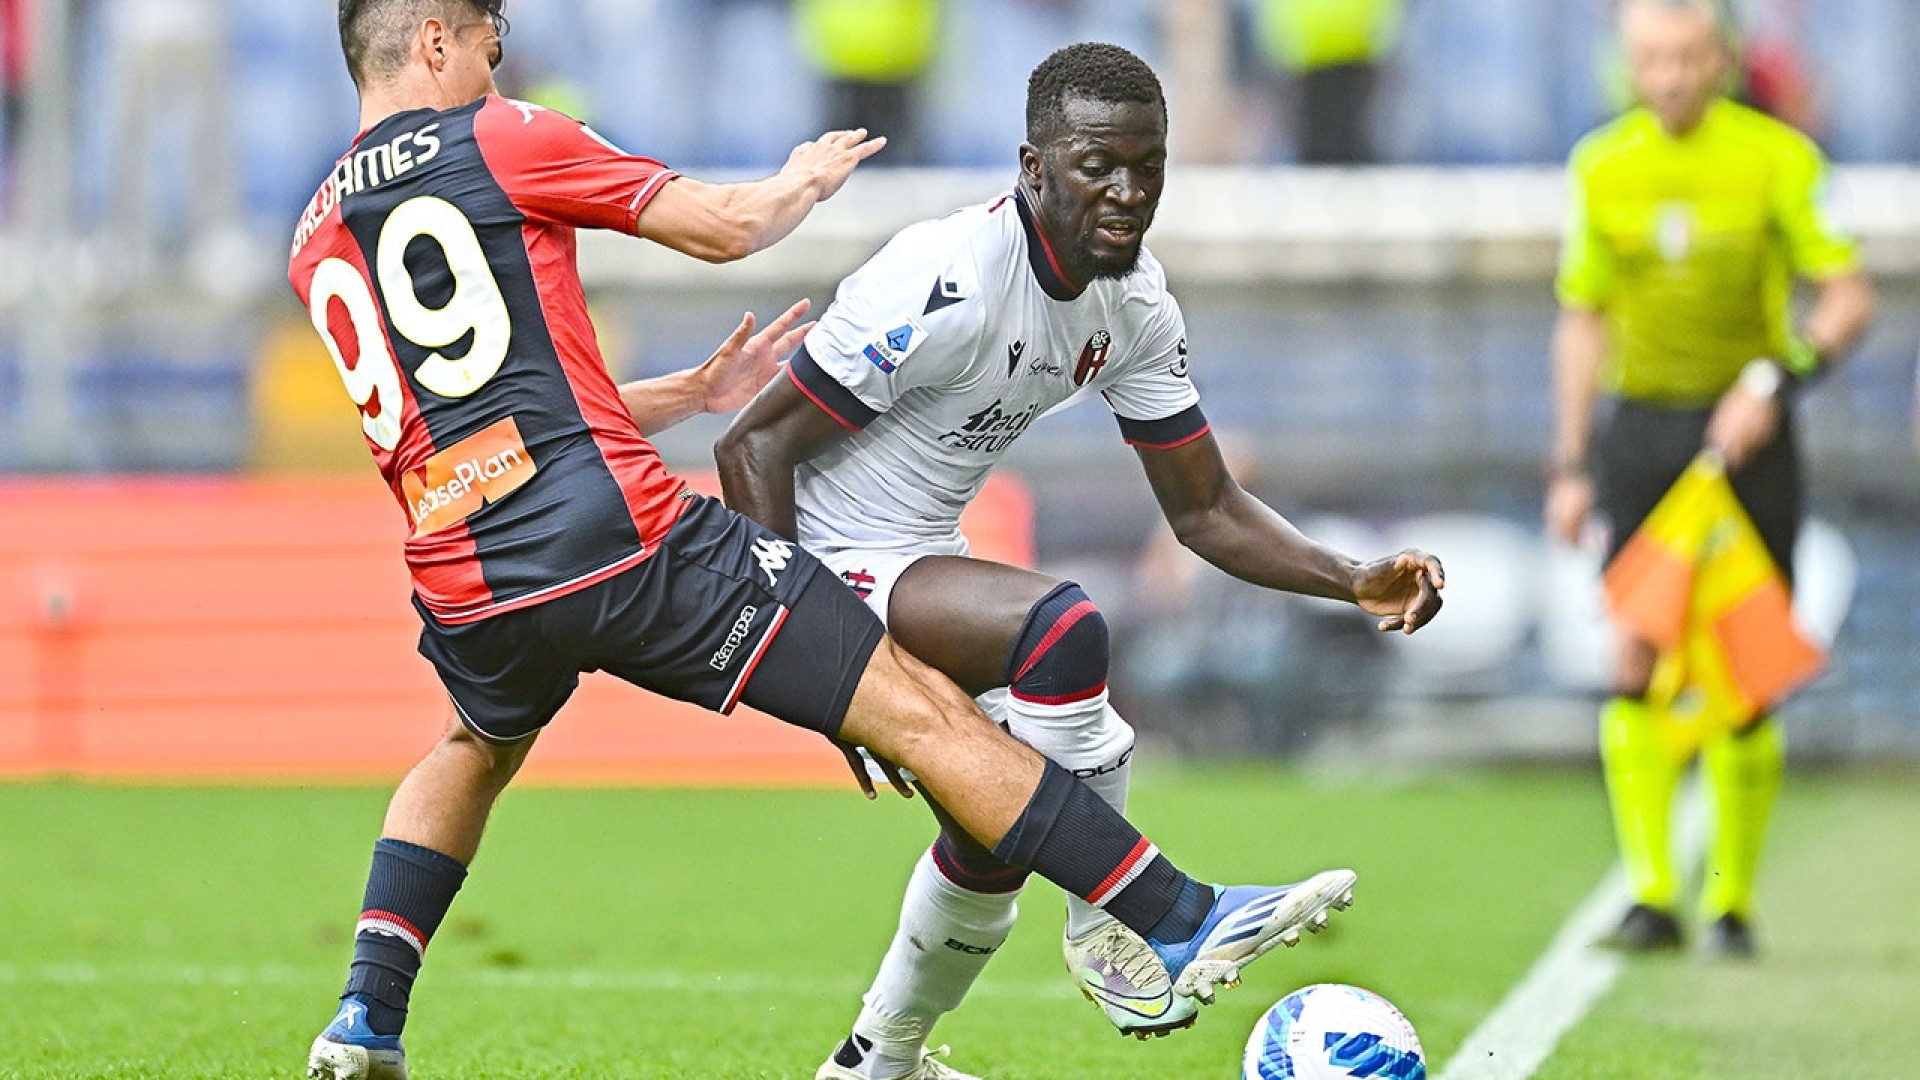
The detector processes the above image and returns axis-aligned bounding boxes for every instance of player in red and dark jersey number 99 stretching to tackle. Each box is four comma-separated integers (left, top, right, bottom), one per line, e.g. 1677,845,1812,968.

288,8,1397,1080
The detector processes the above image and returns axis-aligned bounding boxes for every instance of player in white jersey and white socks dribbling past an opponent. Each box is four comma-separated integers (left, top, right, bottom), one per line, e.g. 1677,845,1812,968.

716,44,1442,1080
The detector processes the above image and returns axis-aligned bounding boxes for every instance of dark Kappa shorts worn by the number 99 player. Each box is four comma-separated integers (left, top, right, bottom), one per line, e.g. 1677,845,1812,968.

415,498,883,742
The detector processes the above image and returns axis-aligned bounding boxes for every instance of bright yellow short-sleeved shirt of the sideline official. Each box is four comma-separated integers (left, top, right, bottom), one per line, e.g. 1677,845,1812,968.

1557,100,1857,405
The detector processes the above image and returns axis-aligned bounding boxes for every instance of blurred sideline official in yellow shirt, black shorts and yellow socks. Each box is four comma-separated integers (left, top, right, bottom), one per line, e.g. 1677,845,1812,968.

1546,0,1874,957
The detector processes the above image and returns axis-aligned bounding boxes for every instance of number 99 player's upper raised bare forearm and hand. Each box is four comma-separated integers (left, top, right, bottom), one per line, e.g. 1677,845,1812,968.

636,127,887,263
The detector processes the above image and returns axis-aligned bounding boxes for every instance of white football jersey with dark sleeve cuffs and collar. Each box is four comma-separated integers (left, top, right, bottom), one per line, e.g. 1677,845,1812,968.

789,194,1206,553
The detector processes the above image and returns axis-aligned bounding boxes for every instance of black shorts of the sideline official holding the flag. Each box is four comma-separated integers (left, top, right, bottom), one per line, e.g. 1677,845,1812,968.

1594,398,1805,586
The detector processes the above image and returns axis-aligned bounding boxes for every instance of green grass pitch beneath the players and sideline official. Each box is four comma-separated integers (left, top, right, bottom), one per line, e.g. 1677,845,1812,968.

0,767,1920,1080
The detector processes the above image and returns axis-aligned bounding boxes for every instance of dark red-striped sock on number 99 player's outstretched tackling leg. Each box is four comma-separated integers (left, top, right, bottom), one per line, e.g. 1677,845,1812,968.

993,761,1212,942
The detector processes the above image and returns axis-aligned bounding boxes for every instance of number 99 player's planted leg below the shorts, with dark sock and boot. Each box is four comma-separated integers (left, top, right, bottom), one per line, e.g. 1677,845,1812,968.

307,721,534,1080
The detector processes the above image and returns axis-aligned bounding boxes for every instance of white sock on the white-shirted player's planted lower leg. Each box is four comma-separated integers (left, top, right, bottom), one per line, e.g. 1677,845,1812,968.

852,851,1020,1078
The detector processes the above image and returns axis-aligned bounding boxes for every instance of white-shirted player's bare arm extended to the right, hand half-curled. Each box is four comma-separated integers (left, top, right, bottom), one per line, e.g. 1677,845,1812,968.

1139,434,1446,634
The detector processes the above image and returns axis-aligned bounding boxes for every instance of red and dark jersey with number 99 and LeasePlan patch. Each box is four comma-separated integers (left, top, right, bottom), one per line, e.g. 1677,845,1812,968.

288,96,685,623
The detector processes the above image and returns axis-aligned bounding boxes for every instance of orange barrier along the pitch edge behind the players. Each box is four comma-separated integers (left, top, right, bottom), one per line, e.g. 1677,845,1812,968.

0,475,1033,784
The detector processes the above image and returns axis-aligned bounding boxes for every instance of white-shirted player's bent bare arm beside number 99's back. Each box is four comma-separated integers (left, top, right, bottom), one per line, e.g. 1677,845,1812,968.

714,363,852,540
